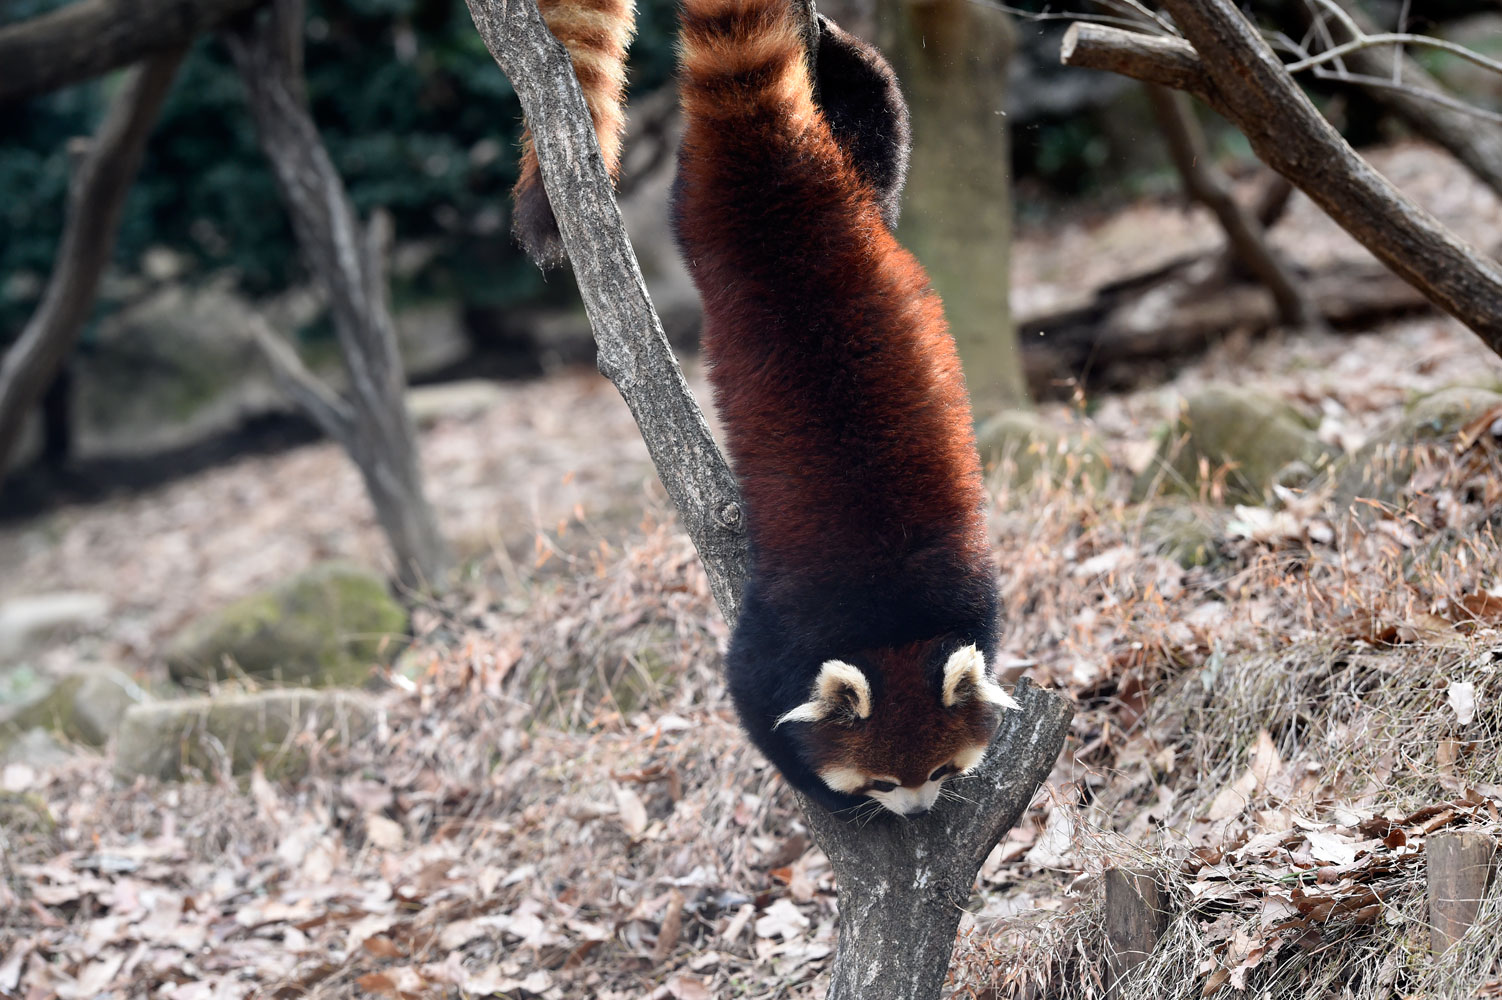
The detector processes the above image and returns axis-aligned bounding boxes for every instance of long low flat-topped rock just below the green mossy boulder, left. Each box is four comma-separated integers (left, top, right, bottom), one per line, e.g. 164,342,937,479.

114,688,379,781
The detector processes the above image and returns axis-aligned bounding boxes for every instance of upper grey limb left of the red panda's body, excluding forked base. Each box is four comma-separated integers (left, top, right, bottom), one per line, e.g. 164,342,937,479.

469,0,746,625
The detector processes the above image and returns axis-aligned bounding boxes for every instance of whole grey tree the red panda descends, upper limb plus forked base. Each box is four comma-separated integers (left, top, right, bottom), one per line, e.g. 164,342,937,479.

469,0,1074,1000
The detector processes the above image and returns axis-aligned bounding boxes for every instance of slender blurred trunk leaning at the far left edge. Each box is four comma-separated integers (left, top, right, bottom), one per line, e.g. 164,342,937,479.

0,47,186,477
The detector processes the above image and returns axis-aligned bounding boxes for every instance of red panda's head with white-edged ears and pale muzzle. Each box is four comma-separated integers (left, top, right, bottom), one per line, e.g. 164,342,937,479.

777,640,1017,815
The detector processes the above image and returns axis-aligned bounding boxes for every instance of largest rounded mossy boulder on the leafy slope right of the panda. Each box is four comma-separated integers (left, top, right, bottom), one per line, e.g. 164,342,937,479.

1133,386,1334,505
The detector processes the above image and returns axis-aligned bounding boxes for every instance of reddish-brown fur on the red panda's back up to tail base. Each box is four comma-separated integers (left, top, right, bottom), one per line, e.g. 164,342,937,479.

679,0,987,594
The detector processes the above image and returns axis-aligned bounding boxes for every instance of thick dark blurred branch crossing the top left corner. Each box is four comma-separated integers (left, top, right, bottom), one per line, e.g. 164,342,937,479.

0,0,263,104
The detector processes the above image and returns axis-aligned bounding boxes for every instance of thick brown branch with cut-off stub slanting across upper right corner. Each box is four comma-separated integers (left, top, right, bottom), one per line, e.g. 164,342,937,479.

1059,11,1502,354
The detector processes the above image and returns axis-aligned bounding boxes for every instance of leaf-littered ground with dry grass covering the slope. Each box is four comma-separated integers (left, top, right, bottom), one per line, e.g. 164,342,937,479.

0,141,1502,1000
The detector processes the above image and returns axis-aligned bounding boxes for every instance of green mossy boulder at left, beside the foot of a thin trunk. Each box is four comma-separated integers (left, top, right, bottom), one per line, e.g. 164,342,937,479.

165,565,407,686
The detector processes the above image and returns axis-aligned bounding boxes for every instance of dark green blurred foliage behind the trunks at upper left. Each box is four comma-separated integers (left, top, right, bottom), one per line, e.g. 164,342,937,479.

0,0,674,334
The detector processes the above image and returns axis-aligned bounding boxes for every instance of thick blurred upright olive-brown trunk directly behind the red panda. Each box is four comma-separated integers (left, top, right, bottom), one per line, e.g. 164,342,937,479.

883,0,1027,417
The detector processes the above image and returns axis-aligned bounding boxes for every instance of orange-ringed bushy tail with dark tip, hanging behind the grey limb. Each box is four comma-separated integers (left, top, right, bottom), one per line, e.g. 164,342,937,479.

512,0,637,267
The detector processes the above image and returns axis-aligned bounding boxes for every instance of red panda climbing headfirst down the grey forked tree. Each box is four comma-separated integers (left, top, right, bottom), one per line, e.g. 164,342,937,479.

673,0,1014,814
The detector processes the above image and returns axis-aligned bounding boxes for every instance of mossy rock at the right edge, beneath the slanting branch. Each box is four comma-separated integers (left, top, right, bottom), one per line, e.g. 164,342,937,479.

1329,386,1502,512
